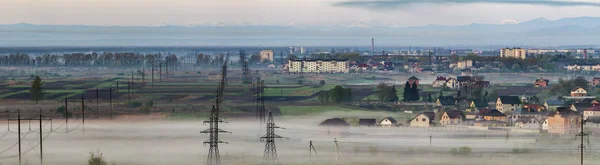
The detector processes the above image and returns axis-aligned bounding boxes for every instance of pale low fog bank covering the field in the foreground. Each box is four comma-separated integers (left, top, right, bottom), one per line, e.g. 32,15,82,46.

0,112,600,165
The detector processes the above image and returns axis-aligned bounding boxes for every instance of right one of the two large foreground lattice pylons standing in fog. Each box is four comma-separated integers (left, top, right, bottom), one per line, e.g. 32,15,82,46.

260,112,284,161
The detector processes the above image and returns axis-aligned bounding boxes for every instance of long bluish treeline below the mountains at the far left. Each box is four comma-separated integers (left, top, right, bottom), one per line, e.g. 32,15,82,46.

0,52,225,67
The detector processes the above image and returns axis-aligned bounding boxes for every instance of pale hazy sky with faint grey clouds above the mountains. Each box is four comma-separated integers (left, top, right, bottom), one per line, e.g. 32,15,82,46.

0,0,600,26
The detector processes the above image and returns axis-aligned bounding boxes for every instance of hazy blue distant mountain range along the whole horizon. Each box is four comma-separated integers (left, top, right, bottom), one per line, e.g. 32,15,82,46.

0,17,600,47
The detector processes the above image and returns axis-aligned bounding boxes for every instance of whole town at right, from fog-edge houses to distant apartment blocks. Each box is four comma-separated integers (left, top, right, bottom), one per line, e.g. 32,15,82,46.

302,48,600,135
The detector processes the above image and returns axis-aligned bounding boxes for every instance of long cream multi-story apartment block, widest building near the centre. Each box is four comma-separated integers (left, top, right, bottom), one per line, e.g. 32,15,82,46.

288,59,350,73
